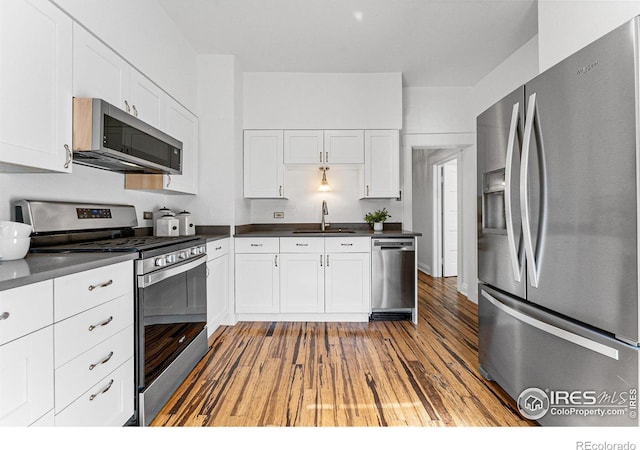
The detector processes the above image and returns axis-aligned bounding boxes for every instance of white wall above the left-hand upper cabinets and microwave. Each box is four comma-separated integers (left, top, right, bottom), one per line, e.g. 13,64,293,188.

53,0,197,112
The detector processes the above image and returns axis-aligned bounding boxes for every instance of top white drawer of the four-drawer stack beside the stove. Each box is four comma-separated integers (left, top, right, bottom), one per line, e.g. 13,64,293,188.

54,261,133,322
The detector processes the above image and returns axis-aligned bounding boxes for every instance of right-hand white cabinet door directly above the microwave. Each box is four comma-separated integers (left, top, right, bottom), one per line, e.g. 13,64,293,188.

129,67,168,128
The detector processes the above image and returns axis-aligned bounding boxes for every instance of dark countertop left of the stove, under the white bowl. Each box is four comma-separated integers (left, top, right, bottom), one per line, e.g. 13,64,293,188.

0,253,138,291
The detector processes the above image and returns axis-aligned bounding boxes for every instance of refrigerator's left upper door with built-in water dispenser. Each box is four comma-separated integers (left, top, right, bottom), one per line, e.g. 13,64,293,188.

477,88,526,298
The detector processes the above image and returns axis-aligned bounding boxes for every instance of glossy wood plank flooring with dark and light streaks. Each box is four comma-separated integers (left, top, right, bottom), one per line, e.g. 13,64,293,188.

151,273,535,427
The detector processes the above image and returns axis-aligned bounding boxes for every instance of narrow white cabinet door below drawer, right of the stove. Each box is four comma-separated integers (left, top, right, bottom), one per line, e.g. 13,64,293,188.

207,254,229,336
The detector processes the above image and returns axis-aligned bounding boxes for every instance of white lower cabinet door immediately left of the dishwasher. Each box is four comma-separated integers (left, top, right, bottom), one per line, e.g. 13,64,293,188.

325,253,371,313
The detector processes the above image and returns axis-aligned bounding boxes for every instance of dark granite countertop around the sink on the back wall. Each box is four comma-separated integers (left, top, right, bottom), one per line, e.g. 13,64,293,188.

234,223,422,238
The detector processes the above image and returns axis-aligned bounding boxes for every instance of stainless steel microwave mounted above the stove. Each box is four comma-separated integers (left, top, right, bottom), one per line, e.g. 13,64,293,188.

73,97,183,175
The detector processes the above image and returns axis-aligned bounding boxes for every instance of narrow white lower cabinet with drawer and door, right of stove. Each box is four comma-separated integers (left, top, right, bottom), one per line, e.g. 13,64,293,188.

207,239,229,336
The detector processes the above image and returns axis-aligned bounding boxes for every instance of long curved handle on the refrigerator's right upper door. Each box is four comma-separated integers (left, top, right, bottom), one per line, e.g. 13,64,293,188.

520,92,538,287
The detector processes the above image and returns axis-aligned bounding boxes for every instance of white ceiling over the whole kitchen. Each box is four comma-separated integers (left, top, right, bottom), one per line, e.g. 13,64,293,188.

158,0,538,87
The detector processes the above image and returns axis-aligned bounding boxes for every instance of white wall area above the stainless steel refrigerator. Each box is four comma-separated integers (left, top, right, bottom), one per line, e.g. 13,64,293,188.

538,0,640,72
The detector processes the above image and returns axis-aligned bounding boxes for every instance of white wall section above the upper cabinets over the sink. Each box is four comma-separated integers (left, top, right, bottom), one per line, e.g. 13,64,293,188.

243,72,402,130
